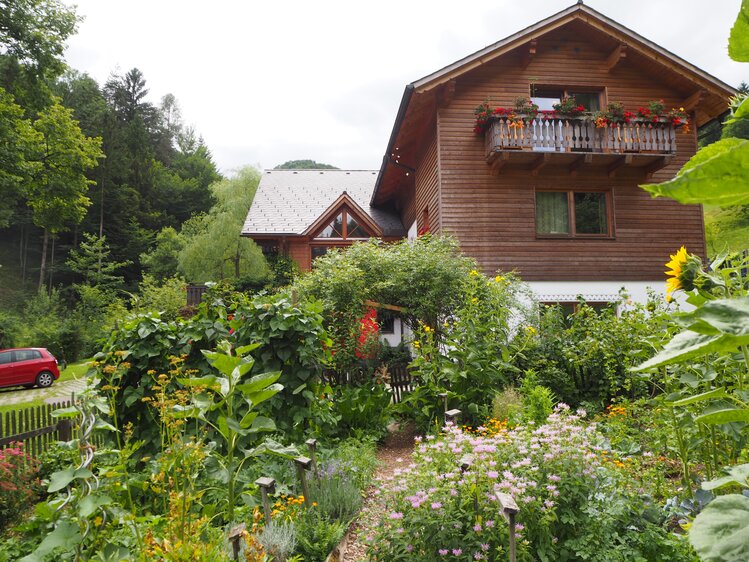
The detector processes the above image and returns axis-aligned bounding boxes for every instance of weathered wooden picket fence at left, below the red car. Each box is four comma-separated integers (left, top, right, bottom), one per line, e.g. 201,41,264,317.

0,397,78,457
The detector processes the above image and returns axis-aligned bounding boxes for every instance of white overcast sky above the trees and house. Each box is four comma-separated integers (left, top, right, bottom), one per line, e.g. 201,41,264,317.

65,0,749,174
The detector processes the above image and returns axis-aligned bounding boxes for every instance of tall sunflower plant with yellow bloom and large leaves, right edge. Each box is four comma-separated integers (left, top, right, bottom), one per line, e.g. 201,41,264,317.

640,0,749,560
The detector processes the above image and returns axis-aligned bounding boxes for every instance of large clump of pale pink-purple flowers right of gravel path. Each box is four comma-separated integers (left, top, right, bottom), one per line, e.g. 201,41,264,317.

369,405,694,561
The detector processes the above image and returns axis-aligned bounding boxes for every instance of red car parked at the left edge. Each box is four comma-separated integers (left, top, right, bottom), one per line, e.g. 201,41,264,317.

0,347,60,388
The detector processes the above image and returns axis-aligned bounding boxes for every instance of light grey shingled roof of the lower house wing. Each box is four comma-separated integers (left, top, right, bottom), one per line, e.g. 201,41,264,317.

242,170,406,237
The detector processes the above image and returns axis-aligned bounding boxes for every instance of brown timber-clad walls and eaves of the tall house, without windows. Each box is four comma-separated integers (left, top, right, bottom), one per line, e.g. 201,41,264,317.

373,5,733,281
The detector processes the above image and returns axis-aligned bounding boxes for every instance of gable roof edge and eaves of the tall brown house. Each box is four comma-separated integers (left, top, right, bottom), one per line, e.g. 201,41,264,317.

371,0,738,204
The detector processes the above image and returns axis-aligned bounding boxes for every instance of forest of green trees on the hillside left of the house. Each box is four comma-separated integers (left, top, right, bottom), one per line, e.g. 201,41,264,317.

0,0,288,358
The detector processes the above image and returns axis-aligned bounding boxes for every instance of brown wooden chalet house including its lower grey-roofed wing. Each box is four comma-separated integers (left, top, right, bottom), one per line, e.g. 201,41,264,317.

242,3,736,303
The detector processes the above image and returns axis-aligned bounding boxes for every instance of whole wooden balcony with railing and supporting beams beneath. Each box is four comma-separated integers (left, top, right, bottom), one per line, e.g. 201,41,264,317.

485,116,676,176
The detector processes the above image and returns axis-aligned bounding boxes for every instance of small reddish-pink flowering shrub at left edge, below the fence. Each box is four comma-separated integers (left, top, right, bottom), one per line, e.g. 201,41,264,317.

0,443,41,528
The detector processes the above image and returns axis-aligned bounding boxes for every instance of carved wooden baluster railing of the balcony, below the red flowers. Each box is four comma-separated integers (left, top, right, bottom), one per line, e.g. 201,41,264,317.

486,116,676,158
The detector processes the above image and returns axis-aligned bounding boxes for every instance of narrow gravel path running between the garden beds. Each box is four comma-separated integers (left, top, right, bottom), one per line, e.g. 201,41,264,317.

341,427,415,562
